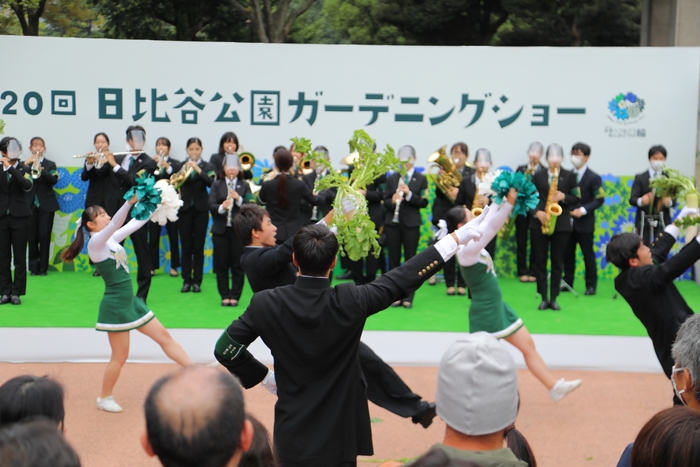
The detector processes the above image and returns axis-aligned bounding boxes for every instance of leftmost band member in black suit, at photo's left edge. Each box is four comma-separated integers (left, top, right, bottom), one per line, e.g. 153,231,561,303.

0,136,32,305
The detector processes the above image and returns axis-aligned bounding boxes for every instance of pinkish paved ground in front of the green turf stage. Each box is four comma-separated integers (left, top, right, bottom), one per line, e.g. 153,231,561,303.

0,363,672,467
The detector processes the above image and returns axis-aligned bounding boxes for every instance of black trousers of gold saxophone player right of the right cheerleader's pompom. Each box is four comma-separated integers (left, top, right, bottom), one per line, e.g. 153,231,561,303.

530,229,571,301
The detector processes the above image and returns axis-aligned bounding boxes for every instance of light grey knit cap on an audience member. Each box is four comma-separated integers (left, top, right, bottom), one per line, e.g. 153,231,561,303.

435,332,518,436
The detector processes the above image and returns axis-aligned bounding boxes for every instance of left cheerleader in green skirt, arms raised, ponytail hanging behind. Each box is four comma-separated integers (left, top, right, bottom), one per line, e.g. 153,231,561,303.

61,194,192,412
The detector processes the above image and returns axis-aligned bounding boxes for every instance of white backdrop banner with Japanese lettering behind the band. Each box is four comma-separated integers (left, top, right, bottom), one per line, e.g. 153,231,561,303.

0,36,700,175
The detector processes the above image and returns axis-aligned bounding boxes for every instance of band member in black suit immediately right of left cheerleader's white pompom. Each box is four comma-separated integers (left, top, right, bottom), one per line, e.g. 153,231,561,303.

177,138,216,293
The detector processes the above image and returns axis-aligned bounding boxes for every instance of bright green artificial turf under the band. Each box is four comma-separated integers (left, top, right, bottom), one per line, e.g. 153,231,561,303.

0,272,700,336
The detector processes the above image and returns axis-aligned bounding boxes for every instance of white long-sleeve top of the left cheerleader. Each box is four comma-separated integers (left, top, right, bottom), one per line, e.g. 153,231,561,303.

88,203,148,272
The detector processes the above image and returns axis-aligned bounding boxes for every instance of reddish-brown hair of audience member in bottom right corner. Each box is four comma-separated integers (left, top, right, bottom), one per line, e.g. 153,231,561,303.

630,406,700,467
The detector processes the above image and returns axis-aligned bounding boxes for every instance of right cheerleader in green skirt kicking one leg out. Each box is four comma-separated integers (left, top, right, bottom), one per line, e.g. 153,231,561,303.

445,188,581,402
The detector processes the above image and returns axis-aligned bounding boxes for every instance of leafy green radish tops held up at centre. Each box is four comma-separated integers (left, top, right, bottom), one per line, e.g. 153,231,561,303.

292,130,401,261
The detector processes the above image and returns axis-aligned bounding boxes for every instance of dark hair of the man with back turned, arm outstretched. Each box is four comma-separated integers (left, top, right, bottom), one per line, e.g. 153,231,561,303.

292,224,338,276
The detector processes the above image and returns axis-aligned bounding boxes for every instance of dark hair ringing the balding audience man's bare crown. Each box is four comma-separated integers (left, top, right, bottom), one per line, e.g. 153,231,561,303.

144,369,245,467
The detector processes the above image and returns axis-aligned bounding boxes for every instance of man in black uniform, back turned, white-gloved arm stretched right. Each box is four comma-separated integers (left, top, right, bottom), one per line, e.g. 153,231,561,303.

215,213,481,467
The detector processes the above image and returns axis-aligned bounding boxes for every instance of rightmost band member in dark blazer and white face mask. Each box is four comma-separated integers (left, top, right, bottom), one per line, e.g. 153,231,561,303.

630,145,674,249
